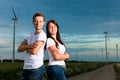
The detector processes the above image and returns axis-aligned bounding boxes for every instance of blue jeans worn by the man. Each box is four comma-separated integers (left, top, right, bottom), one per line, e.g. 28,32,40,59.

21,66,45,80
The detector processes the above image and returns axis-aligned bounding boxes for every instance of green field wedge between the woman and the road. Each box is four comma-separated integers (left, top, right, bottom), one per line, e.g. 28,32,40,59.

65,62,105,77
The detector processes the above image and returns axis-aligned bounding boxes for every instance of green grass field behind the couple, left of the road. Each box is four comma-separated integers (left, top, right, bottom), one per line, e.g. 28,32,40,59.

0,62,105,80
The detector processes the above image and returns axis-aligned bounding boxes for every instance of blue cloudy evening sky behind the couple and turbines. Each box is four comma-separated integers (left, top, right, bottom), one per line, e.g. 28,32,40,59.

0,0,120,61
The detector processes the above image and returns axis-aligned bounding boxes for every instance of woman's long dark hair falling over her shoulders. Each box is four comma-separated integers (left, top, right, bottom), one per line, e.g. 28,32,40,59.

46,20,65,48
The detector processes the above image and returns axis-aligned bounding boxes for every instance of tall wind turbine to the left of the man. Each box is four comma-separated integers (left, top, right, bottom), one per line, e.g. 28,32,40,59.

12,7,18,62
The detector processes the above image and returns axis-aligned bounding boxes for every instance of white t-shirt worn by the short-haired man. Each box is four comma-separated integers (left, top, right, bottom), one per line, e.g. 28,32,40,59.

23,31,46,69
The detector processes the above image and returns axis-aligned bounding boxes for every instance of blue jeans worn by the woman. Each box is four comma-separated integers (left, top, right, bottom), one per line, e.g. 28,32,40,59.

47,65,66,80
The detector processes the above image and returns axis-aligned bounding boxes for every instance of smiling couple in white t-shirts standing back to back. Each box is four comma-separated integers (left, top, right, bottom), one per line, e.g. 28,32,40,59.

17,13,69,80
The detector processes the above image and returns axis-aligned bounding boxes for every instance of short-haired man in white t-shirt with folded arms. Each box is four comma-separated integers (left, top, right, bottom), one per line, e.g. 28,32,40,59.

17,13,46,80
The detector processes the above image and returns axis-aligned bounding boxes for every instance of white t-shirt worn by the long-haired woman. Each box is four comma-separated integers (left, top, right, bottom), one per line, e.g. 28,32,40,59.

46,38,66,66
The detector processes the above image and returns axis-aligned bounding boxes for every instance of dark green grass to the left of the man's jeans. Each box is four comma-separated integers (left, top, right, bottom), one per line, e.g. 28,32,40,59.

0,62,23,80
